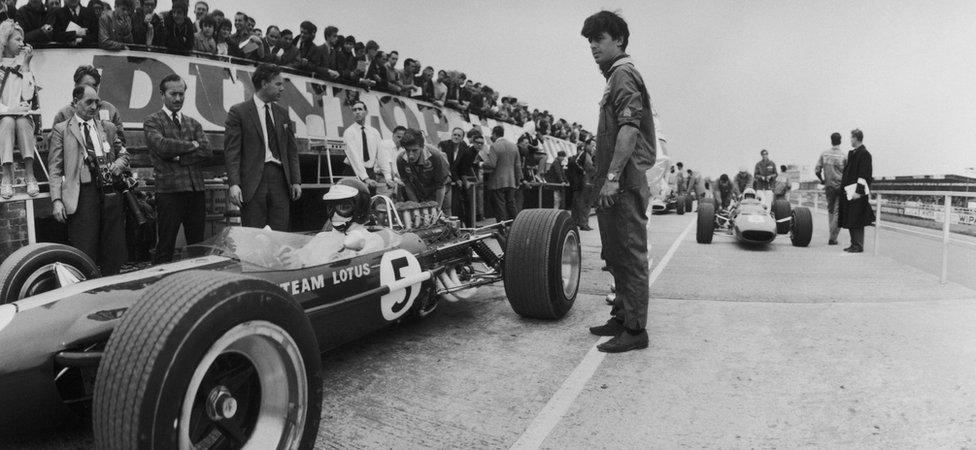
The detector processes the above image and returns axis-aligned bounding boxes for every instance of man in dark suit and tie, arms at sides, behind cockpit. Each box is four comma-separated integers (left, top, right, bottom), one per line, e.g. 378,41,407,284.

224,64,302,231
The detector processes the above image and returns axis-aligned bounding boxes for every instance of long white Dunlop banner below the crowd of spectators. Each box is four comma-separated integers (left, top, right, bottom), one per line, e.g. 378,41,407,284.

31,49,576,159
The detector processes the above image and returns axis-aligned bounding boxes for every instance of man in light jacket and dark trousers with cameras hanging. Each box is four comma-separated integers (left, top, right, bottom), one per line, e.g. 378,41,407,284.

48,86,129,275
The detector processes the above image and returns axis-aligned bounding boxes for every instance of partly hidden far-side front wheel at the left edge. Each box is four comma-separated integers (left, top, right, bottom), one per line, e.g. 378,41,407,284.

0,243,101,305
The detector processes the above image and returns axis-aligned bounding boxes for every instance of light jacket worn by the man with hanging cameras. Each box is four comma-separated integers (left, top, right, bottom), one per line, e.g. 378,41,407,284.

47,115,129,214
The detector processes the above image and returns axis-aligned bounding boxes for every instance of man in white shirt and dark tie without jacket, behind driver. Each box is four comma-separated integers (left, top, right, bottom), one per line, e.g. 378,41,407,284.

342,101,388,191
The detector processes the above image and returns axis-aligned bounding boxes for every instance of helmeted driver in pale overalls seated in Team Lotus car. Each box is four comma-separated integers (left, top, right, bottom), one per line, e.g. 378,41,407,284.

290,178,386,267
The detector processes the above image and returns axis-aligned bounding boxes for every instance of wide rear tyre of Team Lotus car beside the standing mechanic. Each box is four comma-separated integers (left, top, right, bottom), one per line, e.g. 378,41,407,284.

502,209,582,320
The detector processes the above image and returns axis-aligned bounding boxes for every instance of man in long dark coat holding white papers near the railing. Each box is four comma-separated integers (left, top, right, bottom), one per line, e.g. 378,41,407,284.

839,129,874,253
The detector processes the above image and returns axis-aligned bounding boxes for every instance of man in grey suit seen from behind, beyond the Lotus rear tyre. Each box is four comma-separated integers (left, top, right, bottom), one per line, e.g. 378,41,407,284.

484,126,522,222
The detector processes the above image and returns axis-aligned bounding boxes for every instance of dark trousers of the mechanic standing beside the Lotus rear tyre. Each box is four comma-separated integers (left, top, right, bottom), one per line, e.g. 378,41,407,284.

596,184,651,330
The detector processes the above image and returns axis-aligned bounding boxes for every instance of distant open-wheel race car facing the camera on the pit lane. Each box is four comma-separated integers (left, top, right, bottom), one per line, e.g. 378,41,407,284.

696,188,813,247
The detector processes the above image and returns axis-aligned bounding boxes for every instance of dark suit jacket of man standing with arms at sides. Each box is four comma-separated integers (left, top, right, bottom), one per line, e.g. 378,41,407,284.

224,99,302,202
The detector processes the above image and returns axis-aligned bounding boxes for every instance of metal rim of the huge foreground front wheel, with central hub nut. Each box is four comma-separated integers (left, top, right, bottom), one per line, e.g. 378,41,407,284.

178,321,308,449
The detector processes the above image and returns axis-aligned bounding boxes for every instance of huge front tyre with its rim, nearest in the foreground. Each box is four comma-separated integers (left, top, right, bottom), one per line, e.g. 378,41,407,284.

93,271,322,449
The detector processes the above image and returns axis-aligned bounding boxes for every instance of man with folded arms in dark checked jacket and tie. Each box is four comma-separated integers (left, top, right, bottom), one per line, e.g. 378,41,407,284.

142,74,213,264
